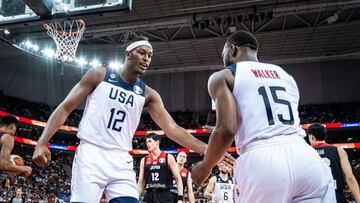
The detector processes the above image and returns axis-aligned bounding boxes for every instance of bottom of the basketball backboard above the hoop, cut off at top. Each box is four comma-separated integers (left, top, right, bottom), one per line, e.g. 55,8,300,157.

0,0,132,26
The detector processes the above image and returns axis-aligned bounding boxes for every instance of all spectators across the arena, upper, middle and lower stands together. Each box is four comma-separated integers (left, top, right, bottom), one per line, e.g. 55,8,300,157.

0,95,360,202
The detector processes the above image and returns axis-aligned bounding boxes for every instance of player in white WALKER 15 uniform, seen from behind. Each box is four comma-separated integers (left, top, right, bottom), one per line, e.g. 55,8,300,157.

192,31,336,203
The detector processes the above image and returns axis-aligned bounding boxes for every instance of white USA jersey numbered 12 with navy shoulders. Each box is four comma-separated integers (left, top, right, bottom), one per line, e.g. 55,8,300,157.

78,69,145,151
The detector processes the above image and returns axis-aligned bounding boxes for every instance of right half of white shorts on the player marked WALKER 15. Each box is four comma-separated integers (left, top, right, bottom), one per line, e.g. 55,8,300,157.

292,142,336,203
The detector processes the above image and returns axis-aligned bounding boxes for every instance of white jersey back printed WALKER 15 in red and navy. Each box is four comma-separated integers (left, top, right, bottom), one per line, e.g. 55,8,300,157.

229,61,305,153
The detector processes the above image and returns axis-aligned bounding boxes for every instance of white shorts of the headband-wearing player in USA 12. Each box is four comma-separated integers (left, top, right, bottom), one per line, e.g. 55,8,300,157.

70,141,139,203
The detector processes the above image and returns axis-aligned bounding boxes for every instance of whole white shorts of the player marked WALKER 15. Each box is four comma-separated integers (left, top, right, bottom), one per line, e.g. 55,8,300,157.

234,135,336,203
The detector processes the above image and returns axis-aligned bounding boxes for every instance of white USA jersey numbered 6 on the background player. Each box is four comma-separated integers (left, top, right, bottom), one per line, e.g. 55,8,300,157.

212,175,234,203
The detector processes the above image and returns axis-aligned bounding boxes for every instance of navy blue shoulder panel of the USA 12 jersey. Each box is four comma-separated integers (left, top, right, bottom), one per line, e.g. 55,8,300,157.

103,68,145,97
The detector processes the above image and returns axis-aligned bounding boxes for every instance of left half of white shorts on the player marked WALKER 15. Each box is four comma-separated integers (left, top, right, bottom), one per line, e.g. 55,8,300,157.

234,139,294,203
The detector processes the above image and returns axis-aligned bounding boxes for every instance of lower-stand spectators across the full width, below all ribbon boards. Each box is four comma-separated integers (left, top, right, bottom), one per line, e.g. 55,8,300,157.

0,153,360,203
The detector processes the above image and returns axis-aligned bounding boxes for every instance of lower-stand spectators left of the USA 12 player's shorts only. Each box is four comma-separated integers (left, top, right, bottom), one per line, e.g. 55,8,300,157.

0,153,73,203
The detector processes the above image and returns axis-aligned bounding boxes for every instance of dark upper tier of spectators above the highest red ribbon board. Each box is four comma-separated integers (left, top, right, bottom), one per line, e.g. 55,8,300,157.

0,95,360,130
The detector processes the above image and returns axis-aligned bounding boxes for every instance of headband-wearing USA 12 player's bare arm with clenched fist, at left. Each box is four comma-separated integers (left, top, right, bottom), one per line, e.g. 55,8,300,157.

33,68,106,166
